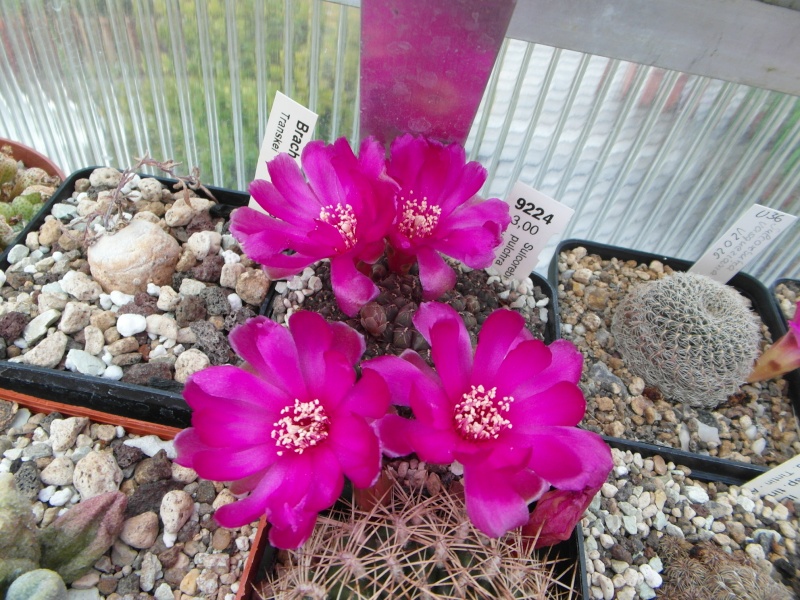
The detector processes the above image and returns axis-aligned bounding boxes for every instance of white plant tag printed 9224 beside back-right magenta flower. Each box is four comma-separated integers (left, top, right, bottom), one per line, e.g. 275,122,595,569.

492,181,575,279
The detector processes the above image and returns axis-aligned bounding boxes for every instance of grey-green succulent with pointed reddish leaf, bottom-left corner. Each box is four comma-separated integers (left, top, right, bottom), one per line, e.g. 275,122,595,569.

0,473,127,597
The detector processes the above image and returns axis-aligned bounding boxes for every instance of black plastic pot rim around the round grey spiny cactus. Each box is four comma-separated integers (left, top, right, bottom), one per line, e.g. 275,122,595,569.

548,239,800,483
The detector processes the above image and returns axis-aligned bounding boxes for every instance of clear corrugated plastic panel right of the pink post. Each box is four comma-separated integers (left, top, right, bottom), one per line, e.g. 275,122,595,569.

468,40,800,284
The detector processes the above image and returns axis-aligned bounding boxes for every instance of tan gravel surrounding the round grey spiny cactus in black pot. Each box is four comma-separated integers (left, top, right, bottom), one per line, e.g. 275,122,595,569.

558,247,800,466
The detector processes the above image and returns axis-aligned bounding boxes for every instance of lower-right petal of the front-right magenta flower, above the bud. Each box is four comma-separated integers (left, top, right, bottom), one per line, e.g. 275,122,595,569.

528,427,613,490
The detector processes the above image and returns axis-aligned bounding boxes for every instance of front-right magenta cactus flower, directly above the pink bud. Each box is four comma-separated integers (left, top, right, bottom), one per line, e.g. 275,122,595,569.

362,303,612,537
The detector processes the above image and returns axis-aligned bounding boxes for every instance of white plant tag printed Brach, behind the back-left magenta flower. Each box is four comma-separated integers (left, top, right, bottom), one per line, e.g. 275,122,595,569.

249,92,317,212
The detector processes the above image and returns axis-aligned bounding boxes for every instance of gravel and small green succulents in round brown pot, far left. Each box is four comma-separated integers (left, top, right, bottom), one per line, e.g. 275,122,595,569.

0,146,61,247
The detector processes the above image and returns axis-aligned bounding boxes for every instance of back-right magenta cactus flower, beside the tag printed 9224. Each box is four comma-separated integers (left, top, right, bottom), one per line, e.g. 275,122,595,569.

387,135,511,300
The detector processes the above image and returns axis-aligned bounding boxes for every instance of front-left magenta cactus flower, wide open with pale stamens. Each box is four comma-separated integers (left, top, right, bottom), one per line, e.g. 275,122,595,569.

175,311,389,548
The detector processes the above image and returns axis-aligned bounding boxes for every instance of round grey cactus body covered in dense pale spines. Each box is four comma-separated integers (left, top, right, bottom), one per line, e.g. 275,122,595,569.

611,273,760,408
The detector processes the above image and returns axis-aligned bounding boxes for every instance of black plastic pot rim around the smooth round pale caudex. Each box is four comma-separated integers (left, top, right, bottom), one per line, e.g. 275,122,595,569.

0,167,258,427
